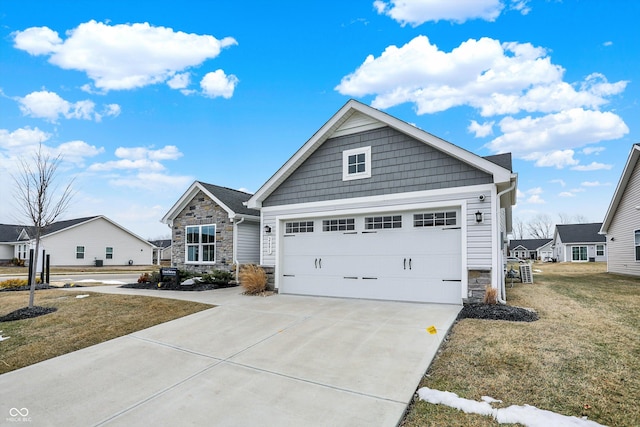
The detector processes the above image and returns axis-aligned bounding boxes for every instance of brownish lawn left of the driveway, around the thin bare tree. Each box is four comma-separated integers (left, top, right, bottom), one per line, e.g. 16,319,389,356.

0,290,212,374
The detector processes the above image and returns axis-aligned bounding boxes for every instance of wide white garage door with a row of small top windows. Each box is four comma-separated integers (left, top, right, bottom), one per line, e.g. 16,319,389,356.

280,209,462,304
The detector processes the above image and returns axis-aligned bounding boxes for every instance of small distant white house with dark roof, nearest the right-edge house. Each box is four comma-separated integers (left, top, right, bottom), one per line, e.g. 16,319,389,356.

553,222,607,262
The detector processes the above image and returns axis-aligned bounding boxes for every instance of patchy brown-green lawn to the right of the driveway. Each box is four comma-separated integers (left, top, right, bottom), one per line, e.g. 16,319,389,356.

403,263,640,426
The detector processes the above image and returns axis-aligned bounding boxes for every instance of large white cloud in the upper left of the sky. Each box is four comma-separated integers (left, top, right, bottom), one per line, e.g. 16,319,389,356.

13,20,237,92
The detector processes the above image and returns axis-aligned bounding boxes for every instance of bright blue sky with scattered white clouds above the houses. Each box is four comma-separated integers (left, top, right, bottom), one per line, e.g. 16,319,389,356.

0,0,640,238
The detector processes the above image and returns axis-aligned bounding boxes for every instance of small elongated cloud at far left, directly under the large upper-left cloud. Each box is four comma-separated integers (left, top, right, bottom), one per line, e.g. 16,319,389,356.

17,90,120,123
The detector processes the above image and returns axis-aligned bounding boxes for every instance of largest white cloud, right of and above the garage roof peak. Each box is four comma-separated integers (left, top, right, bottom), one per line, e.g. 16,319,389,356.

335,35,627,117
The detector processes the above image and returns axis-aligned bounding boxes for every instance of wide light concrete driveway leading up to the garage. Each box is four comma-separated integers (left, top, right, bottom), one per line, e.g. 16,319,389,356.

0,286,461,427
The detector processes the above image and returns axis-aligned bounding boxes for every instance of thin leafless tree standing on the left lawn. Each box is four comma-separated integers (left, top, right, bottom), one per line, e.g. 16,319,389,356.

12,144,73,308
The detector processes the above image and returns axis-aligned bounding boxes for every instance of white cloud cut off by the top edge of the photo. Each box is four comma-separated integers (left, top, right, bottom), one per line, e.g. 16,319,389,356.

373,0,504,27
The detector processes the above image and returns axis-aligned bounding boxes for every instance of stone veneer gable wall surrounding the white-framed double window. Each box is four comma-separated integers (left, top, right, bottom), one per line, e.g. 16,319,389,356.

171,191,233,273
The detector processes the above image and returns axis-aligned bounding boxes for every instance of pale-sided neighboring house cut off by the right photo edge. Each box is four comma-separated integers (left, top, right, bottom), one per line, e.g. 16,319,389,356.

600,144,640,276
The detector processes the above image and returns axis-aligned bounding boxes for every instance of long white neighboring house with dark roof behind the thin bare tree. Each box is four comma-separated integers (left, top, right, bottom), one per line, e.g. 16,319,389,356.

0,215,153,266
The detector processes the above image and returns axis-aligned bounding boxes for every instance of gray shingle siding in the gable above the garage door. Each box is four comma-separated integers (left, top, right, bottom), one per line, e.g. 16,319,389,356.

262,127,493,207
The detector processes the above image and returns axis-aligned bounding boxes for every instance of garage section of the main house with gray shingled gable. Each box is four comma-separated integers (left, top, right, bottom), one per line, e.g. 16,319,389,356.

249,100,517,304
